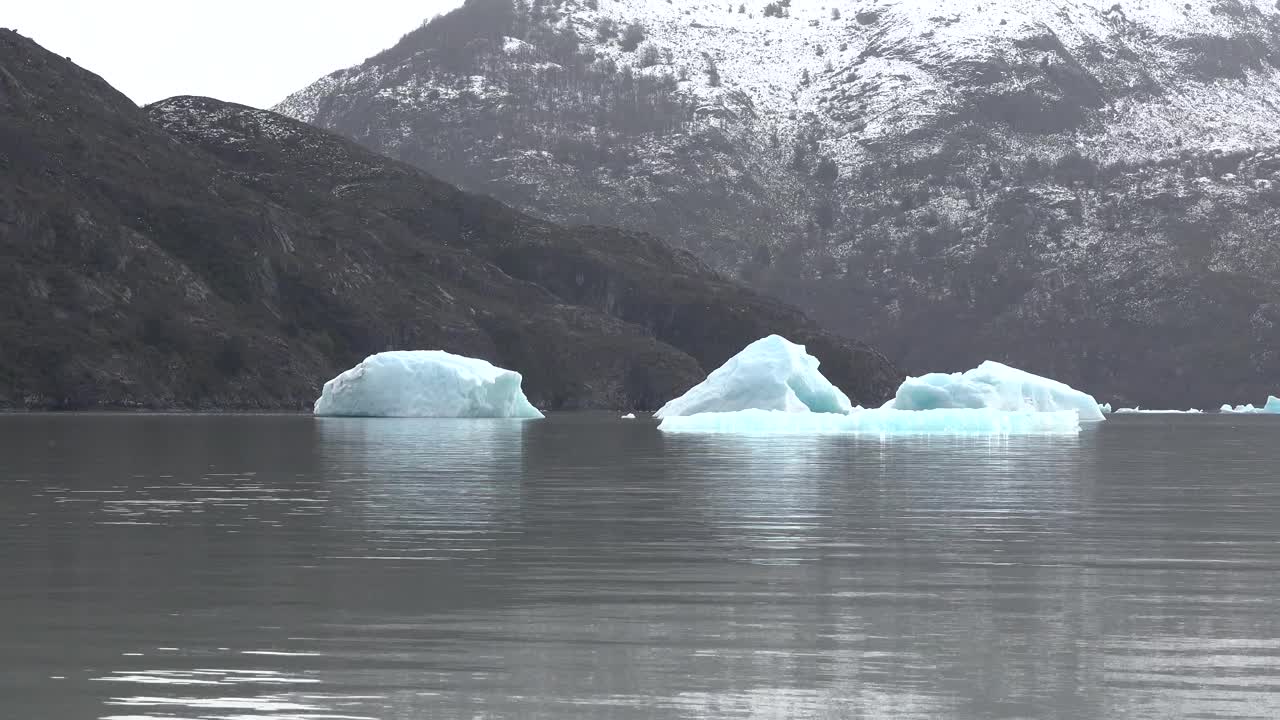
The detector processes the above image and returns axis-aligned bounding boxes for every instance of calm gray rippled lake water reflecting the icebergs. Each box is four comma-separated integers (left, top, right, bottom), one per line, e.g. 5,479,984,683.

0,415,1280,720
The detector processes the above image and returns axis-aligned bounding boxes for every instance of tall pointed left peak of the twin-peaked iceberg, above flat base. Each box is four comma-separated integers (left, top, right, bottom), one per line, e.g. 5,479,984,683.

654,336,852,419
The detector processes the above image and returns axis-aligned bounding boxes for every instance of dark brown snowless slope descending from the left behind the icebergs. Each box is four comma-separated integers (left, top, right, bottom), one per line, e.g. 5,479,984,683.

0,31,901,409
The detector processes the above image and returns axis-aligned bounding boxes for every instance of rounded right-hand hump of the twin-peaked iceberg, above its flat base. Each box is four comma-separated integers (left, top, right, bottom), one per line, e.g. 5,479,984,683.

884,360,1106,423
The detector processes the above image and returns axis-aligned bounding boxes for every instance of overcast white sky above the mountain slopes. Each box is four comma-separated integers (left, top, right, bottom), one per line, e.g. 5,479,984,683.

0,0,462,108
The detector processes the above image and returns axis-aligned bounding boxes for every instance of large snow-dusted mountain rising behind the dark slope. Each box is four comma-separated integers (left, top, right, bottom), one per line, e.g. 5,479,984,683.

278,0,1280,406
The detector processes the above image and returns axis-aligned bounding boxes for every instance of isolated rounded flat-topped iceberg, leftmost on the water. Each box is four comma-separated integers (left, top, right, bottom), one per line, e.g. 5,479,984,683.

315,350,543,419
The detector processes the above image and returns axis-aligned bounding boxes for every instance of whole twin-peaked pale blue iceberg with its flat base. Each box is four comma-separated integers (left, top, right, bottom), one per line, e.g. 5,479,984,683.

657,336,1105,436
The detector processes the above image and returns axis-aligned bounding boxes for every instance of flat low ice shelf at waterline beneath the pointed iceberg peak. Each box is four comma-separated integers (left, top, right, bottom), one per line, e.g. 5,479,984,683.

658,409,1080,436
